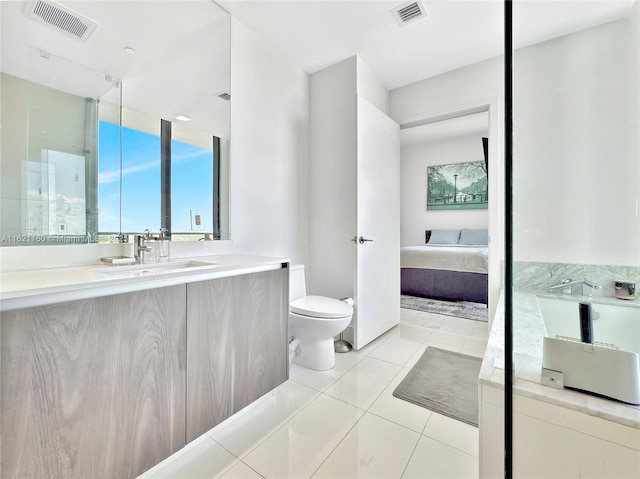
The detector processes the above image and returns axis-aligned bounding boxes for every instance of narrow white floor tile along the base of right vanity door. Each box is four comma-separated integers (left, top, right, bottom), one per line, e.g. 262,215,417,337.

211,380,320,458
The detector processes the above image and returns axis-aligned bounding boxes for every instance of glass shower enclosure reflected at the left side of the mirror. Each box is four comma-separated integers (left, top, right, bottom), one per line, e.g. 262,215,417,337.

0,48,118,246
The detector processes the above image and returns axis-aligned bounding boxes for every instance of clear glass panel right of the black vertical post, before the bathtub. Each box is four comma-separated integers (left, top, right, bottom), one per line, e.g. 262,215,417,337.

512,1,640,477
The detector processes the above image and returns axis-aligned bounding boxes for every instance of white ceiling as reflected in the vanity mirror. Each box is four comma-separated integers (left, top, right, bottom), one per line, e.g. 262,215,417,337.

0,0,230,137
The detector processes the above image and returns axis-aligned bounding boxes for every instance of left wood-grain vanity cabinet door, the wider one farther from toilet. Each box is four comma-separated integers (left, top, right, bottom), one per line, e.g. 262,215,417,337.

1,285,186,479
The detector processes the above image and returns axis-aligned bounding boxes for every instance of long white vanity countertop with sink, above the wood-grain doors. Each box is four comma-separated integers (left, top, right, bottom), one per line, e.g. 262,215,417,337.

0,254,289,311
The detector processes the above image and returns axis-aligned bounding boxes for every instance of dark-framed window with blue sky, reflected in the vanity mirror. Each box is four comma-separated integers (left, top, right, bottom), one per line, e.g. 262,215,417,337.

98,108,220,241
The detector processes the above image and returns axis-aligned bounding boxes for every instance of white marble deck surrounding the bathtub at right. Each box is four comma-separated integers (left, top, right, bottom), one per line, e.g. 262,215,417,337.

479,292,640,429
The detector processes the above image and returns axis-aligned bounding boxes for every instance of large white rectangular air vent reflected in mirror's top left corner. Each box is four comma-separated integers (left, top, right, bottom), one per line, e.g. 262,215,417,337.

25,0,98,42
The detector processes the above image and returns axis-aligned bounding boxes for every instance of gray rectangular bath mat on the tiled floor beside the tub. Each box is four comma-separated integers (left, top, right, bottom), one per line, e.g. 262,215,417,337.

393,347,482,427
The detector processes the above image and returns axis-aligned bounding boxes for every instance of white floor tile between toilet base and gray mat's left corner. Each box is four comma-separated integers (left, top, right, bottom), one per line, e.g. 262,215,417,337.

325,357,401,409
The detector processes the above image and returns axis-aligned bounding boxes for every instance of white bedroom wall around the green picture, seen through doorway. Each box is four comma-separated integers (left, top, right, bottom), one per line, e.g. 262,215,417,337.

400,132,489,246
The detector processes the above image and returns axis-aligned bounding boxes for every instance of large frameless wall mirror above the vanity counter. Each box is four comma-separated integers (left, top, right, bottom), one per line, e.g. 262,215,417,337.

0,0,230,246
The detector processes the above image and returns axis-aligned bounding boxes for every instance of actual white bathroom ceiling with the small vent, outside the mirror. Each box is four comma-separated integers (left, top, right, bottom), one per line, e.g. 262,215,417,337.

216,0,633,90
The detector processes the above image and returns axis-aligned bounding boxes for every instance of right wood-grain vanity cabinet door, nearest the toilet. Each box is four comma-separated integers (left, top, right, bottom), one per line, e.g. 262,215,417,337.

187,268,289,442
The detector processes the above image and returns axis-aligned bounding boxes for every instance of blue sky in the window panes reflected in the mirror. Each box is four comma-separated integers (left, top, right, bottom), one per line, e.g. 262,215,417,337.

98,121,213,233
